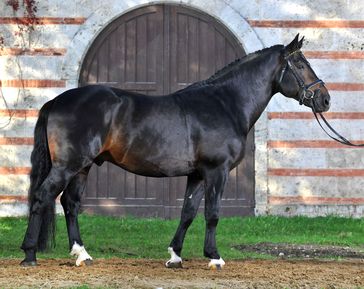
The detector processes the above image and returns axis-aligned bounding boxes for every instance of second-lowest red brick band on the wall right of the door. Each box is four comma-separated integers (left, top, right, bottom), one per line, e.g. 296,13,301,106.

268,168,364,177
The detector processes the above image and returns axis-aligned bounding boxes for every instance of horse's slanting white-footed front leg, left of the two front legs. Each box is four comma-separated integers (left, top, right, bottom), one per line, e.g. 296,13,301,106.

166,175,204,268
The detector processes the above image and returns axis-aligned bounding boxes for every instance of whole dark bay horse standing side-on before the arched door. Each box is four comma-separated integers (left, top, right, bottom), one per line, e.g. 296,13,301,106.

21,35,330,268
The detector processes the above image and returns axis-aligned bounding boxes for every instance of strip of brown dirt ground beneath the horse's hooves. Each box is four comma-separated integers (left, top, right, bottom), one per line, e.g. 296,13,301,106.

0,259,364,289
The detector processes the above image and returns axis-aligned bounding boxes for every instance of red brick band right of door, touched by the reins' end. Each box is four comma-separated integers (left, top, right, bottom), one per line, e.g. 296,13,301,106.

267,140,364,149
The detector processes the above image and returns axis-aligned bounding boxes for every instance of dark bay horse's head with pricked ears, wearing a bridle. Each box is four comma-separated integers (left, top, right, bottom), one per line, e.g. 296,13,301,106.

278,34,330,112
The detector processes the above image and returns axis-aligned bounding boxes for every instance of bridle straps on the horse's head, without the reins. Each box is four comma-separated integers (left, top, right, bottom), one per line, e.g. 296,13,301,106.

279,50,325,105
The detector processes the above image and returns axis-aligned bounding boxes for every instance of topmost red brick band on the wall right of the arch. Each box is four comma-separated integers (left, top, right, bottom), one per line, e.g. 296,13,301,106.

248,20,364,28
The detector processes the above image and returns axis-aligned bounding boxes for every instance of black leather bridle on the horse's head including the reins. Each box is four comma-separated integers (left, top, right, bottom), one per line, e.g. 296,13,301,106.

279,50,364,147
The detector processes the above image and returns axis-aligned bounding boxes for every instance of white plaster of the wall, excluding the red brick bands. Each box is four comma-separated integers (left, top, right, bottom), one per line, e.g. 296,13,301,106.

0,0,364,216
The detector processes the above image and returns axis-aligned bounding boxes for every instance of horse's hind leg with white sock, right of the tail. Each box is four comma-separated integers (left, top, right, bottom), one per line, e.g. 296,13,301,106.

61,167,92,266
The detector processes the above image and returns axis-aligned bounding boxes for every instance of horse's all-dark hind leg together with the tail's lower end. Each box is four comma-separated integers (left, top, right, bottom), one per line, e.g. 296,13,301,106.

21,168,70,266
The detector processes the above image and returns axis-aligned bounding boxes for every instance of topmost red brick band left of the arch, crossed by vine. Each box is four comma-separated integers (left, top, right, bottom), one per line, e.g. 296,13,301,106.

0,17,86,25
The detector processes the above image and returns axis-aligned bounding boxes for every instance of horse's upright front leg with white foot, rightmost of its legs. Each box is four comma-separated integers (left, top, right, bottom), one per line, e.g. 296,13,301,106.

204,165,229,270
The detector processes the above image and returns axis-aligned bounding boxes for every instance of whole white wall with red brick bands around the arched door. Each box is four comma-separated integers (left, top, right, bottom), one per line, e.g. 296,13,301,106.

0,0,364,217
